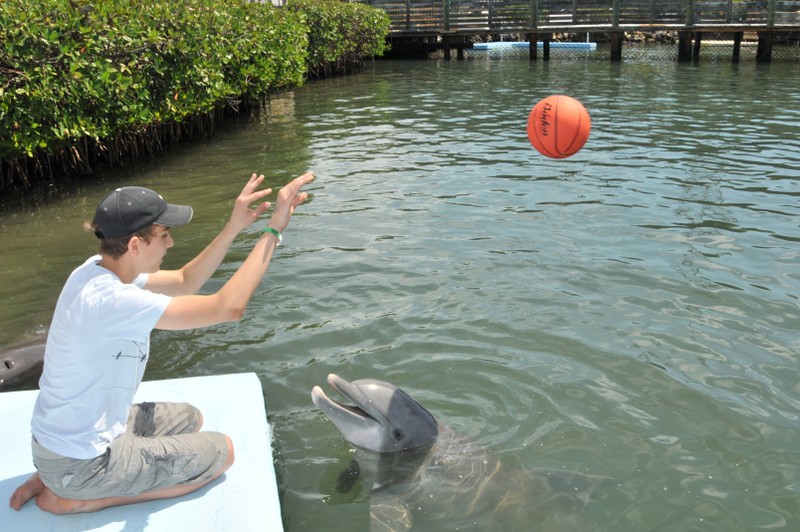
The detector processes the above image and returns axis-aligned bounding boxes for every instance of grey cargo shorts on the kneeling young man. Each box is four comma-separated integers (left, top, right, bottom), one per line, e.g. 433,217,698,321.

32,403,228,500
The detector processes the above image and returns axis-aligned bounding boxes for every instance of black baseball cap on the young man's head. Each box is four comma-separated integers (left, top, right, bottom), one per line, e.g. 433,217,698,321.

93,187,192,238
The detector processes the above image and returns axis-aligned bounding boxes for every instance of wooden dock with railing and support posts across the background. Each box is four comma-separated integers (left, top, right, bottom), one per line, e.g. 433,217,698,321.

363,0,800,62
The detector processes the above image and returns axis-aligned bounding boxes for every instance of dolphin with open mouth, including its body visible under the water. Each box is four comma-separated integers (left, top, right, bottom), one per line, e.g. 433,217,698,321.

311,374,619,532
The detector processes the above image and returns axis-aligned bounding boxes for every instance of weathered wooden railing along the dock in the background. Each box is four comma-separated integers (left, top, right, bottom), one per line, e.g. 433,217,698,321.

361,0,800,35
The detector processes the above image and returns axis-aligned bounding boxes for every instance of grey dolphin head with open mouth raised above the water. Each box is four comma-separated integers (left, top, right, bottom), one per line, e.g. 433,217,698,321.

311,373,439,453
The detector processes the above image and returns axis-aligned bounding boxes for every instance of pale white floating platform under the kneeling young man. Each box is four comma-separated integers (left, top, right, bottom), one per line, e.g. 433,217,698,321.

0,373,283,532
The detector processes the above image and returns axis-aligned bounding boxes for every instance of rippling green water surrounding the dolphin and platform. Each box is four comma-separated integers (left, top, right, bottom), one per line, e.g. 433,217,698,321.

0,60,800,531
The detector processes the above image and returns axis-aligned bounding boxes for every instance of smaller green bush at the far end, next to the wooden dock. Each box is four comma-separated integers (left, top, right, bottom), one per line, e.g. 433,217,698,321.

288,0,391,77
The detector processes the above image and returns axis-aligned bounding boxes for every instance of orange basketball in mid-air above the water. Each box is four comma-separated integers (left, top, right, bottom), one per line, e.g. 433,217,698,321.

528,94,592,159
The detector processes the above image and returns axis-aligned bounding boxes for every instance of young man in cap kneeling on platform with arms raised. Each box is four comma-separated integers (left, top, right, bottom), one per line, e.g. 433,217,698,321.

10,172,314,513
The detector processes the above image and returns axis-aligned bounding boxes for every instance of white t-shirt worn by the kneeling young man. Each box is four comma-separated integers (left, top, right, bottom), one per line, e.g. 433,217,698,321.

31,255,171,459
